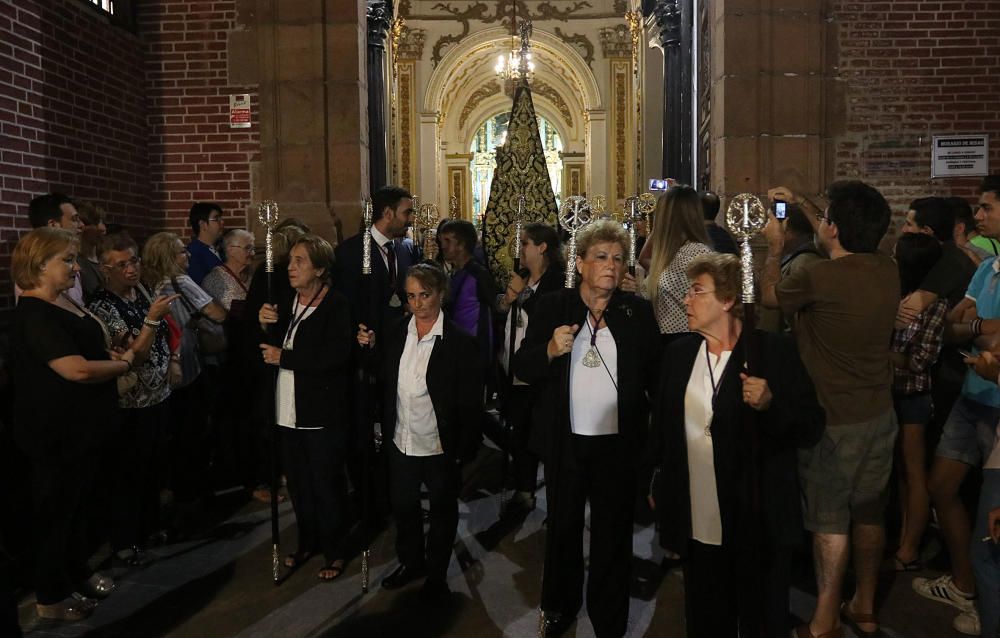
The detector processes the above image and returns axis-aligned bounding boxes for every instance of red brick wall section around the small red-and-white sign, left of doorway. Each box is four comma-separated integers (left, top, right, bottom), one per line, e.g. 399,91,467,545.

138,0,260,237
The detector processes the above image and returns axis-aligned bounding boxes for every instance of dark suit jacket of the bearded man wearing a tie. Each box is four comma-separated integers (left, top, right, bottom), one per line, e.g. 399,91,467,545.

333,233,420,332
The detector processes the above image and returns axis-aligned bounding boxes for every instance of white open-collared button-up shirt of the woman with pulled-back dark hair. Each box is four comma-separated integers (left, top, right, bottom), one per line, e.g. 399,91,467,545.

392,312,444,456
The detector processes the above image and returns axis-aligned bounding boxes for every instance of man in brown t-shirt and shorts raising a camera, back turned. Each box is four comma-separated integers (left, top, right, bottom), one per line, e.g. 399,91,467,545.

761,181,899,638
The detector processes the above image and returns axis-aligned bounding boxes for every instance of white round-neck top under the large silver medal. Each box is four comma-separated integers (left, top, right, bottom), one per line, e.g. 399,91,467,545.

569,317,618,436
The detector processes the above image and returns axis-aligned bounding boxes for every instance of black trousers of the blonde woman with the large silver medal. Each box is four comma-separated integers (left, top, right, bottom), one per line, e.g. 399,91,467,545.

542,434,634,638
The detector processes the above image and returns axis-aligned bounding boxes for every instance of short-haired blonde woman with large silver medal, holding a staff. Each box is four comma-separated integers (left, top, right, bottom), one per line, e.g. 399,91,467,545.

514,216,660,637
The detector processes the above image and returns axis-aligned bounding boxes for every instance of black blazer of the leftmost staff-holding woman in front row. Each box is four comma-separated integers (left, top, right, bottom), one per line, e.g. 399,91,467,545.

270,290,357,432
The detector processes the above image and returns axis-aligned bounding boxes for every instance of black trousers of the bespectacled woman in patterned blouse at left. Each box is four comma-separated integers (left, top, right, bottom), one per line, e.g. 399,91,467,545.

111,402,167,551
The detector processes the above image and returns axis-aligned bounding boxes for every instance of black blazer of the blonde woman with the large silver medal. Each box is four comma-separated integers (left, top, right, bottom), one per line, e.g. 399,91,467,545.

514,288,661,462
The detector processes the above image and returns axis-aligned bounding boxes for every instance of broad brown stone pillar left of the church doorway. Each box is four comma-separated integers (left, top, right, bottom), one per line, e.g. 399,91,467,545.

256,0,369,240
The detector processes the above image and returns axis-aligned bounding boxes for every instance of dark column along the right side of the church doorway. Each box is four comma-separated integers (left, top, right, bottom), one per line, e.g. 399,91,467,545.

646,0,694,184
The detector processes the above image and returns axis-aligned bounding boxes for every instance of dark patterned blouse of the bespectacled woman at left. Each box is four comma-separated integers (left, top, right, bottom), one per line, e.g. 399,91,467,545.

89,289,170,408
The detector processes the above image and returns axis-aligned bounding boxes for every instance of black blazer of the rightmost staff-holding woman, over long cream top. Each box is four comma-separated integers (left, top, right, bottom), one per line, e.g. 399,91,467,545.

649,330,825,555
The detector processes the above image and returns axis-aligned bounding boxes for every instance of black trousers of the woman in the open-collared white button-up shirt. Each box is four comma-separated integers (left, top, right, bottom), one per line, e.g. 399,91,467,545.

387,441,461,581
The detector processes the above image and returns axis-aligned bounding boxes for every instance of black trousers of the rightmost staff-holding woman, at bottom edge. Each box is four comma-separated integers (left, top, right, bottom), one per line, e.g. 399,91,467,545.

684,539,792,638
